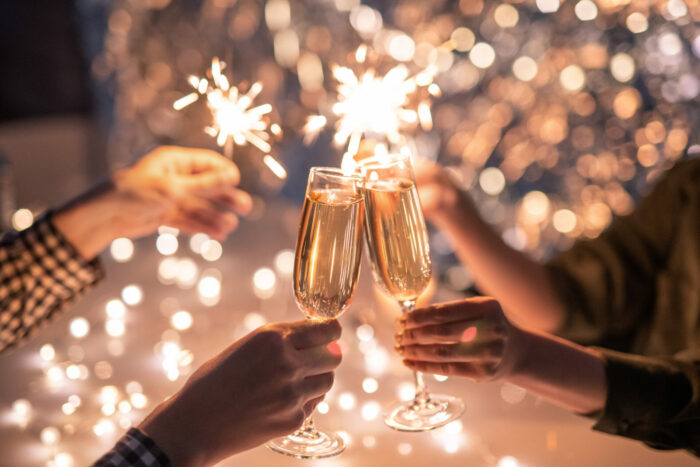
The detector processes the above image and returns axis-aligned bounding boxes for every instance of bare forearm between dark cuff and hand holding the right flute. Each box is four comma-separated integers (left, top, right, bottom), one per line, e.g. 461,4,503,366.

505,330,607,413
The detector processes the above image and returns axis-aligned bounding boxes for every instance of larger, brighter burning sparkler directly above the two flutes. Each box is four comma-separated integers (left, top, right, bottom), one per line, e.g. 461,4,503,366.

304,45,440,161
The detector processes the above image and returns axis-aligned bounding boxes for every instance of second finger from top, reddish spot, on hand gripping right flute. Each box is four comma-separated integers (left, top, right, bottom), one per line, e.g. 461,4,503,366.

395,319,507,345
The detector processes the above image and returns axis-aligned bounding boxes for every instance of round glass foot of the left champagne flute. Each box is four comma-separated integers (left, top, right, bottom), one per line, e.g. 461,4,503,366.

266,428,345,459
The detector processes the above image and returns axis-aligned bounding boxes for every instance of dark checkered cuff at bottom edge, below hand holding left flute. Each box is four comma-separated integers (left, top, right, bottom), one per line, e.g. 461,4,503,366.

93,428,172,467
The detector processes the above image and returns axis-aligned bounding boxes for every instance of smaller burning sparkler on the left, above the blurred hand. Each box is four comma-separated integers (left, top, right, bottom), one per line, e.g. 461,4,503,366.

173,57,287,178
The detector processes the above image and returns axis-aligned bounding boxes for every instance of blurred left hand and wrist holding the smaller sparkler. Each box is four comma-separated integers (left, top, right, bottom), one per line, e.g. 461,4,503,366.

54,147,251,259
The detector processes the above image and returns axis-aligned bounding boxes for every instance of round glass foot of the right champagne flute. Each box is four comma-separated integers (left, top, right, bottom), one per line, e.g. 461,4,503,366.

384,394,464,431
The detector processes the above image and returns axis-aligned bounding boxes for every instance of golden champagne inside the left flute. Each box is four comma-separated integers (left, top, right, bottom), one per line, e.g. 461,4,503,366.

294,189,364,318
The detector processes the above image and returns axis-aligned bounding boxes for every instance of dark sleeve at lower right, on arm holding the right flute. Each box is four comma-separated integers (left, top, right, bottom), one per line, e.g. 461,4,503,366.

589,348,697,449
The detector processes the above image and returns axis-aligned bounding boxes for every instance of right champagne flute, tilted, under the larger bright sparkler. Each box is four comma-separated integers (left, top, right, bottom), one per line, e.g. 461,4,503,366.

360,154,464,431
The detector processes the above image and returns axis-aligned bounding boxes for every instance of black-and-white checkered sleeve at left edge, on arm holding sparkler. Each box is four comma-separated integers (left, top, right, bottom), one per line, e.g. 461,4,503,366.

0,211,104,352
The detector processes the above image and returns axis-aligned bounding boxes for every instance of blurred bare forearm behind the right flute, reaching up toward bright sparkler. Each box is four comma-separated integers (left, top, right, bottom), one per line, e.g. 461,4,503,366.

433,199,565,332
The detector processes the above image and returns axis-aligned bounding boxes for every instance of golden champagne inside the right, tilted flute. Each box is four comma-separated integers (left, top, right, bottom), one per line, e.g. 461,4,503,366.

364,179,431,302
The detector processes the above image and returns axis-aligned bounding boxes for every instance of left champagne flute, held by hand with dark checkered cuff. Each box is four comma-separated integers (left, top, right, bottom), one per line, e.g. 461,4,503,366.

267,167,364,459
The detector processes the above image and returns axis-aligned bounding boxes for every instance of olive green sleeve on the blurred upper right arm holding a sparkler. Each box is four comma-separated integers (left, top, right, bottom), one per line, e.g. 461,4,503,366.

545,161,688,349
